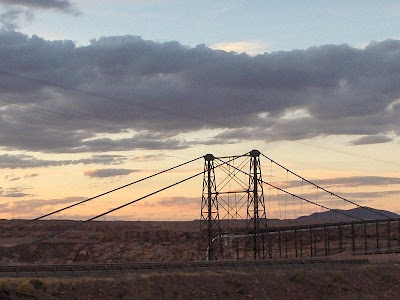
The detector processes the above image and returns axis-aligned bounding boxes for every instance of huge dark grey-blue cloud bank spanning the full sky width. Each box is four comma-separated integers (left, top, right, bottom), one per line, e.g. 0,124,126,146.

0,32,400,153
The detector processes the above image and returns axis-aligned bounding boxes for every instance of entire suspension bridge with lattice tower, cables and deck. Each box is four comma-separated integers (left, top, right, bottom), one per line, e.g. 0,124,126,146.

0,150,400,272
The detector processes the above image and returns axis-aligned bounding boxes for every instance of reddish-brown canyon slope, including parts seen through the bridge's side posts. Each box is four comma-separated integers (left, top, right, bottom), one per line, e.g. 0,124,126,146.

0,220,400,265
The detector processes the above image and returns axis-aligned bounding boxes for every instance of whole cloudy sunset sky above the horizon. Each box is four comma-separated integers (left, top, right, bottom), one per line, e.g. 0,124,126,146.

0,0,400,220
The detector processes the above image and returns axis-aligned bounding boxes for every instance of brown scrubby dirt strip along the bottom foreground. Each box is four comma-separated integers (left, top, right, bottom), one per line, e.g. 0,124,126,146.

0,265,400,300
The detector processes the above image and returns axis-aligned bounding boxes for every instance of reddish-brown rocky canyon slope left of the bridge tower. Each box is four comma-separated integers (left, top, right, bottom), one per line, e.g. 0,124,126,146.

0,221,199,265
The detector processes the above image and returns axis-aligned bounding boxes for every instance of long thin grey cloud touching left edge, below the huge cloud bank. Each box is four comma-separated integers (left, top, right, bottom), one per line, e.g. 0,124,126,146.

0,154,127,169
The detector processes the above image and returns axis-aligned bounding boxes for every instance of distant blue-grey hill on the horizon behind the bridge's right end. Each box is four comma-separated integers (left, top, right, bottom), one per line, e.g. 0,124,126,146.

293,207,400,225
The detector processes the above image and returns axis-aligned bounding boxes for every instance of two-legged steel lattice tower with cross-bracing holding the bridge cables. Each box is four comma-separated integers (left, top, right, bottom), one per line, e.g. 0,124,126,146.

199,150,267,260
